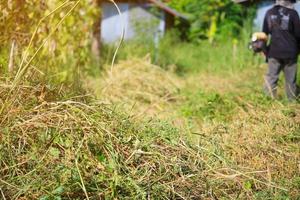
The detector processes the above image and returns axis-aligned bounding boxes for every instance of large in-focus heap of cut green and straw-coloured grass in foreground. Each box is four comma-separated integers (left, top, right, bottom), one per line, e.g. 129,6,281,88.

0,74,298,199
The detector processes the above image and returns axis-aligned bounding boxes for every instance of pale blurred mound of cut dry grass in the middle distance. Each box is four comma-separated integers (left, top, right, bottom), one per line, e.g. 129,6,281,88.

87,58,181,117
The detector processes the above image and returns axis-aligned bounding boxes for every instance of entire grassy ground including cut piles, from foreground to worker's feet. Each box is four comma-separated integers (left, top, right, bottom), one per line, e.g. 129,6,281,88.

0,38,300,200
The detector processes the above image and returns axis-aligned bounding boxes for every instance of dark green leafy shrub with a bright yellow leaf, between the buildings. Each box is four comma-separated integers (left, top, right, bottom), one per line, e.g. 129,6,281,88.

169,0,251,41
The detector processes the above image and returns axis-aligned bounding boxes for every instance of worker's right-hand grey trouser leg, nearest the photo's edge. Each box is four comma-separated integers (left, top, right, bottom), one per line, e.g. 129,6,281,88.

283,60,298,101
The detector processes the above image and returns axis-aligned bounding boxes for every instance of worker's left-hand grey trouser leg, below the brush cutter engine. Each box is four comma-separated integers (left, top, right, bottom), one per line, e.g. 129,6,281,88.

264,58,282,98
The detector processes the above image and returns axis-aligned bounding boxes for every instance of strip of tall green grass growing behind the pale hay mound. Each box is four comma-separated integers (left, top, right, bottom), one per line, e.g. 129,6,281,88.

101,32,263,75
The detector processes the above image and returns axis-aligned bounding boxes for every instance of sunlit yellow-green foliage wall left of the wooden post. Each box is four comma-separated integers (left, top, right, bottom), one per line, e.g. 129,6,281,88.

0,0,100,81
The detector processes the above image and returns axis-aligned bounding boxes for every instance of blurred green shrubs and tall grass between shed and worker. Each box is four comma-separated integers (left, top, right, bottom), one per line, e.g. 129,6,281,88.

101,0,261,74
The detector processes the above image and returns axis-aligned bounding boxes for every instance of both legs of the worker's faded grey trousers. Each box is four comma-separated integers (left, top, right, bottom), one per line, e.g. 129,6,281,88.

265,58,298,100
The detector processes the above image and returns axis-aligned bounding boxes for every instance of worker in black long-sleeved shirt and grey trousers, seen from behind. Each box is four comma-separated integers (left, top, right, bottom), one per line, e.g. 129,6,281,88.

263,0,300,101
